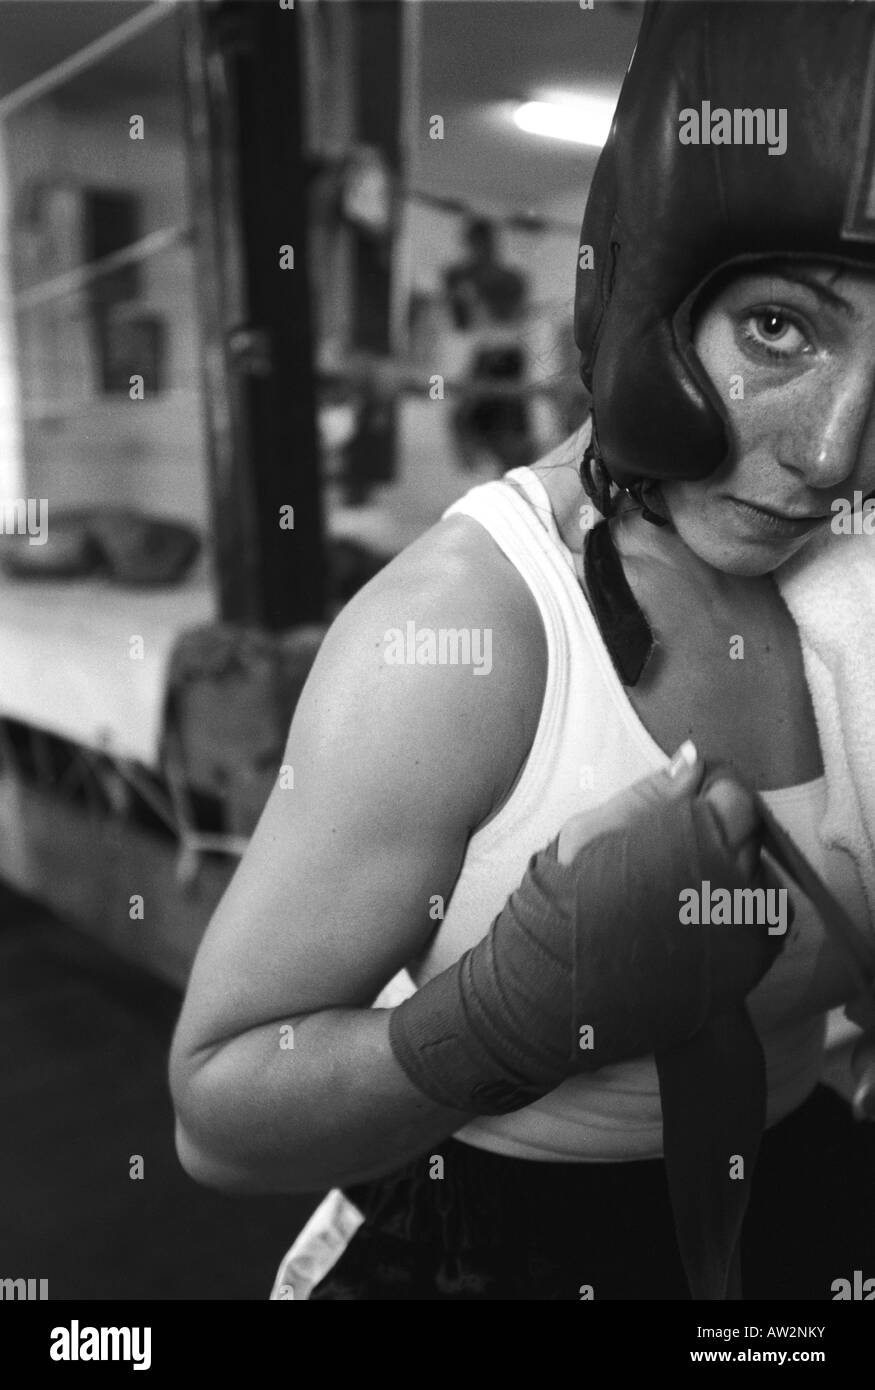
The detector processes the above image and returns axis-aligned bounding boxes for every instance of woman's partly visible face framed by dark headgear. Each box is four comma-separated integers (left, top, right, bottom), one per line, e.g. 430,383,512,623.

662,261,875,575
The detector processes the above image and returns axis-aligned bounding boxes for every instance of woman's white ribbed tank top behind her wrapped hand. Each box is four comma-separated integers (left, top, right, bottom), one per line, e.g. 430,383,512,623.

409,468,868,1162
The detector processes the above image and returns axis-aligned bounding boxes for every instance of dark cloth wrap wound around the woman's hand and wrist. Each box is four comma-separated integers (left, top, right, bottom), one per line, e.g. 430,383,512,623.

390,795,780,1115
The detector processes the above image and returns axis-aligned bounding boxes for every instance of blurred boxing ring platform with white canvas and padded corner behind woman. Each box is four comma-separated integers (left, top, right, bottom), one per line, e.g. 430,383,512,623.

0,558,324,986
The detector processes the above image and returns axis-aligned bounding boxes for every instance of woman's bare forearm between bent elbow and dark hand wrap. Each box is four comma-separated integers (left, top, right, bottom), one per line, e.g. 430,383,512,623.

171,1009,470,1193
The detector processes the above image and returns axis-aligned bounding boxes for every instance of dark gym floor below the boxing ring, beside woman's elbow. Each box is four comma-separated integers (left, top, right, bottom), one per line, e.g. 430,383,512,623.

0,883,319,1301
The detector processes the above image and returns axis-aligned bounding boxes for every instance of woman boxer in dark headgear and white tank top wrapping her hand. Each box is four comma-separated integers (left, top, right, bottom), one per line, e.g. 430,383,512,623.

171,4,875,1300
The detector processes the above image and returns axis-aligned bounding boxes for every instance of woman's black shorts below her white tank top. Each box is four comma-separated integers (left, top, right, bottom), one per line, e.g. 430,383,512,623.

310,1086,875,1301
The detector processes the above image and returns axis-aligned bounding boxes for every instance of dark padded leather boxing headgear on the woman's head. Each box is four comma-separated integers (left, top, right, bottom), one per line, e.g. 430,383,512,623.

575,0,875,487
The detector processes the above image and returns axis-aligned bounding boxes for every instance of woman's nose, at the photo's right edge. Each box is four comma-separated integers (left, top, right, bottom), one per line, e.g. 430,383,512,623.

782,364,875,488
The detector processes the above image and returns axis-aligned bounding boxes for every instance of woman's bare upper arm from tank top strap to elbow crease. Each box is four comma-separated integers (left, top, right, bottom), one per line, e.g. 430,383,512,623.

174,518,545,1059
